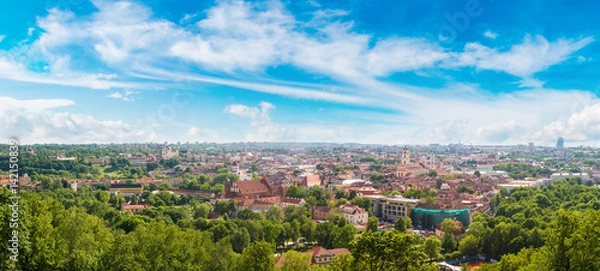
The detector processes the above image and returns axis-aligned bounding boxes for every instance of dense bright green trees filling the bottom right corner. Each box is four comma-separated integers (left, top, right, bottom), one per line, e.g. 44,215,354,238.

459,178,600,270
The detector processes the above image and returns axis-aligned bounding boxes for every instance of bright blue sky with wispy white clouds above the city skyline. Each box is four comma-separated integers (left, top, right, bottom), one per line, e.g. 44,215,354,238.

0,0,600,146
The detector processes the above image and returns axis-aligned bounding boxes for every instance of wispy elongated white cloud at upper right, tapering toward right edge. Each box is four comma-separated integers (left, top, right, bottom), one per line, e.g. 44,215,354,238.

449,36,594,77
